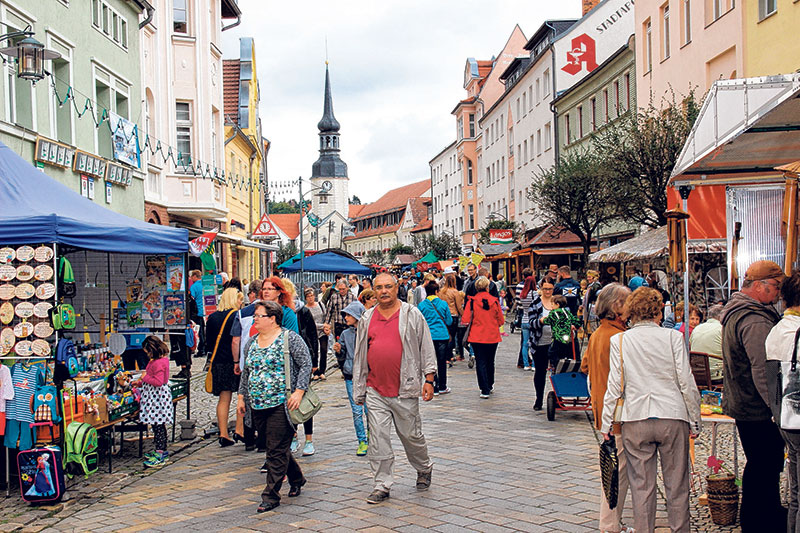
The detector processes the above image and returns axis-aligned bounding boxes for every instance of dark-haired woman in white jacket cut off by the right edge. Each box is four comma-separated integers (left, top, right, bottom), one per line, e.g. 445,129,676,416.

765,270,800,533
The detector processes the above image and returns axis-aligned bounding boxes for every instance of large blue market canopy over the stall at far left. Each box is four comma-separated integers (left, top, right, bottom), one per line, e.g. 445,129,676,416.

0,142,189,254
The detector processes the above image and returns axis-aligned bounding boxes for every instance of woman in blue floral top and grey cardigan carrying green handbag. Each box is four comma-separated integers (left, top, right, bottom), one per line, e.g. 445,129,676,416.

237,301,311,513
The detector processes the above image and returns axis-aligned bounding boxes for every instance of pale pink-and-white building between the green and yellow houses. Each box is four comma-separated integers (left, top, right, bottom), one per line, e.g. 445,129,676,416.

141,0,241,264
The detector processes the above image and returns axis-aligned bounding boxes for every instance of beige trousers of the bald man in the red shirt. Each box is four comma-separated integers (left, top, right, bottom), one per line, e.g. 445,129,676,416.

364,388,433,492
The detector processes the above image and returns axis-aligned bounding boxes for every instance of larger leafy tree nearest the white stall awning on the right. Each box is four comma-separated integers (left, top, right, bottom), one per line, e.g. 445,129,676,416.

592,90,700,228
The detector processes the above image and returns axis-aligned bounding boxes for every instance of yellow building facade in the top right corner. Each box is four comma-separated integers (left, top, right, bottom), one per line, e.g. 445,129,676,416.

743,0,800,77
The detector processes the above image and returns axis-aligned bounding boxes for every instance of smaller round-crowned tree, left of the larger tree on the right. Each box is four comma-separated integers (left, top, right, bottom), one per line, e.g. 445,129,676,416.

528,150,619,265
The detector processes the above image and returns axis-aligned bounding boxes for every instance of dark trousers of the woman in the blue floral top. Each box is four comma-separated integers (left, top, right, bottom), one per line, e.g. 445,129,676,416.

252,404,305,503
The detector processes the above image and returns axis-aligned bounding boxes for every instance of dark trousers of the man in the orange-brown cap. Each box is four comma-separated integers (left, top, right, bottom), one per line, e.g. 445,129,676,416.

736,420,787,533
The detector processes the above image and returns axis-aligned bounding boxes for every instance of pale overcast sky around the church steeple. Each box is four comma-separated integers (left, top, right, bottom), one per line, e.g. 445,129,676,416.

223,0,581,202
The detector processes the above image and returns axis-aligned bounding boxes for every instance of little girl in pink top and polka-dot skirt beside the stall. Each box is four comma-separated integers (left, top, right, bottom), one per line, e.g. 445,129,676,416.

136,335,172,468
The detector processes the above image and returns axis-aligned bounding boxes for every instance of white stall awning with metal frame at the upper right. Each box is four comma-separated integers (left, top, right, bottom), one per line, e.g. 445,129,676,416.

670,73,800,187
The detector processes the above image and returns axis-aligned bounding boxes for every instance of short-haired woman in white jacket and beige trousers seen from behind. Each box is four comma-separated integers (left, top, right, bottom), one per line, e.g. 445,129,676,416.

602,287,701,532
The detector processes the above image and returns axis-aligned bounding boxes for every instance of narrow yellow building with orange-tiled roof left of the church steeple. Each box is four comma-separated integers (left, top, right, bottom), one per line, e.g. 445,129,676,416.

223,37,268,281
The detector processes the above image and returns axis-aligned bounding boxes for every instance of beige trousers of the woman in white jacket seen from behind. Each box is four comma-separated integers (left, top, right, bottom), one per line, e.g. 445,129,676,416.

622,419,689,533
